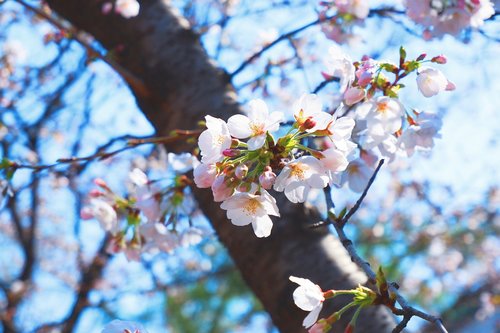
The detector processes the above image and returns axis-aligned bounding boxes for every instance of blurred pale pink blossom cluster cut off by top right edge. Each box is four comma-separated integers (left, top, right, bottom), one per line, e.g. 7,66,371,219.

406,0,495,39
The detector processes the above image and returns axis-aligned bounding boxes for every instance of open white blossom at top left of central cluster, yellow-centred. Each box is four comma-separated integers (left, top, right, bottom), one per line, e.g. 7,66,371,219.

228,99,284,150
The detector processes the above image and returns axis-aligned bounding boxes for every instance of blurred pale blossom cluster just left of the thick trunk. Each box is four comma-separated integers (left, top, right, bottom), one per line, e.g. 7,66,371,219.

81,153,206,260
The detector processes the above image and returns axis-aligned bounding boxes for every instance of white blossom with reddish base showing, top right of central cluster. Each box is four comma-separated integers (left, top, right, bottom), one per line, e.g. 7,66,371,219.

292,94,332,133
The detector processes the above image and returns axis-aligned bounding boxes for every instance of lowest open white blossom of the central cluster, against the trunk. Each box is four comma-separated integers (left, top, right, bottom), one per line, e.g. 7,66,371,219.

220,190,280,238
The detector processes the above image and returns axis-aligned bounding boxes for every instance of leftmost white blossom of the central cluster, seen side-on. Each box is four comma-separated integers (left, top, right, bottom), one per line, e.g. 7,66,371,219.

198,116,231,164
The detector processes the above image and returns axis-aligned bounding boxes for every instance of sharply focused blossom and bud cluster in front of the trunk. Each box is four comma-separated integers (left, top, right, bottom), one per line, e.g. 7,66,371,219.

194,94,356,237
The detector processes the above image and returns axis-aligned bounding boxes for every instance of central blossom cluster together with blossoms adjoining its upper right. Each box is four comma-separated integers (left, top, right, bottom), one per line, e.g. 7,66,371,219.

194,48,454,237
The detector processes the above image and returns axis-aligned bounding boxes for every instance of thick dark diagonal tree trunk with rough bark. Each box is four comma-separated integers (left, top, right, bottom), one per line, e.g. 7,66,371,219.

47,0,394,333
